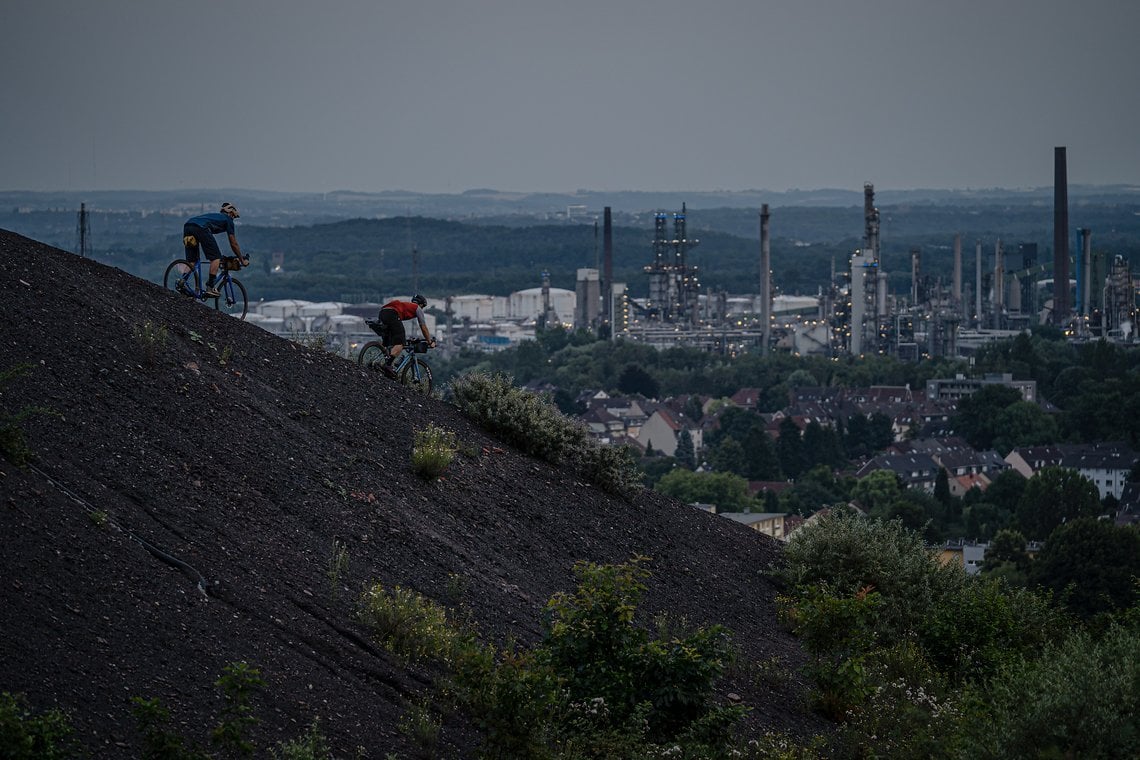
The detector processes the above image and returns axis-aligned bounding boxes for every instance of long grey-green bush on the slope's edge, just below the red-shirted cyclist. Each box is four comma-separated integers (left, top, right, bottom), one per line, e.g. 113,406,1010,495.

451,373,642,499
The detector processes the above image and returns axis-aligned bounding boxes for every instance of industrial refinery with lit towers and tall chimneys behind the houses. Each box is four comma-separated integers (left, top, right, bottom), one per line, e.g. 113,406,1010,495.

588,147,1135,360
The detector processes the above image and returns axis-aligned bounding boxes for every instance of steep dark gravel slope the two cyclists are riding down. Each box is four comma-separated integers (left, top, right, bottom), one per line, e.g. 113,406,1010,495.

0,230,827,758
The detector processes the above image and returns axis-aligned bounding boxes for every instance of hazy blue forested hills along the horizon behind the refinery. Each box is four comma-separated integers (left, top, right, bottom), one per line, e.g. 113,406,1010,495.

0,186,1140,301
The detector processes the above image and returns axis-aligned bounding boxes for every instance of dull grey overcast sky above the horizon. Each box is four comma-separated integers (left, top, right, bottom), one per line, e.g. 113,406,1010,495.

0,0,1140,193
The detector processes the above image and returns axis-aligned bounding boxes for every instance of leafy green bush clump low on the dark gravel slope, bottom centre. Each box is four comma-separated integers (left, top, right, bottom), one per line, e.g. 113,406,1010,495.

361,558,744,760
